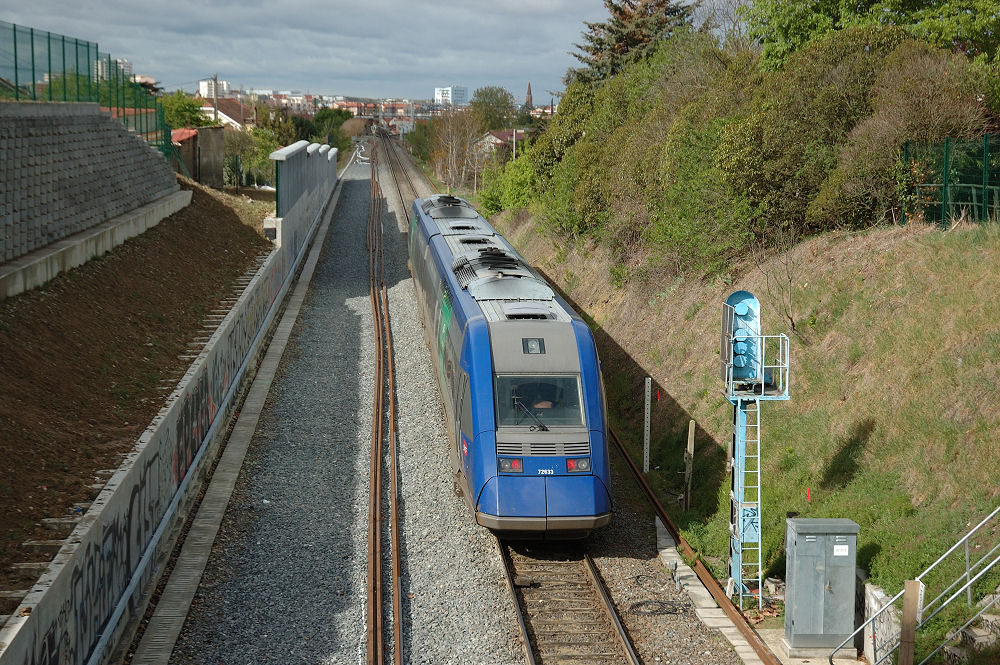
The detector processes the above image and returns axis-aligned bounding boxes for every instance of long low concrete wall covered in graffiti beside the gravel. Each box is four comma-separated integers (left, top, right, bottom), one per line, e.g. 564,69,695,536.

0,141,337,665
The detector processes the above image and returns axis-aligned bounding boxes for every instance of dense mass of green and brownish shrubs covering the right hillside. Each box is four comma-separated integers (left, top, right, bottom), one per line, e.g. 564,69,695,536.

496,16,1000,282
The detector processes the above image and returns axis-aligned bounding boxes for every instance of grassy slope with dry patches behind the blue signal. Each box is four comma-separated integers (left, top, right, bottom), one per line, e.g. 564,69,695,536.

497,216,1000,590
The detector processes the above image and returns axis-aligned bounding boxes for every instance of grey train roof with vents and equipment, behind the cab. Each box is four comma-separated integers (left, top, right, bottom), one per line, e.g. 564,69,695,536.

418,195,572,322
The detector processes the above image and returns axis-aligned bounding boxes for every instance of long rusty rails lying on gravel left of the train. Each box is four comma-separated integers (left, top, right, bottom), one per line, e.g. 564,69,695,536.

365,141,402,665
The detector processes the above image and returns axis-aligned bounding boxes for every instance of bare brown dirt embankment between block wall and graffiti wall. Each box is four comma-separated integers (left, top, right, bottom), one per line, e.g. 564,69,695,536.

0,181,273,600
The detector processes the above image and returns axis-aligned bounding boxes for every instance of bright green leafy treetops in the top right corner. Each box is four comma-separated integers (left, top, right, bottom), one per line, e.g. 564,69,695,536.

746,0,1000,69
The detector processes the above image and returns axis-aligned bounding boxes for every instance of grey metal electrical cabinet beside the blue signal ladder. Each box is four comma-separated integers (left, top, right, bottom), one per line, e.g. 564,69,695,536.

785,517,858,648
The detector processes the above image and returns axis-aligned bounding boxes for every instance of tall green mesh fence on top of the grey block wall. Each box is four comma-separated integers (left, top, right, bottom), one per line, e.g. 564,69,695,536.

0,21,174,159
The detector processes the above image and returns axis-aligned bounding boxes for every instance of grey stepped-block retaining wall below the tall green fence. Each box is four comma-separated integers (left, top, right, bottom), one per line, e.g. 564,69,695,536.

0,102,178,262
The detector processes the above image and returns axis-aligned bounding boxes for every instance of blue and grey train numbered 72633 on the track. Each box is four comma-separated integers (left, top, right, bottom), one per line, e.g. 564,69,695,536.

409,195,611,539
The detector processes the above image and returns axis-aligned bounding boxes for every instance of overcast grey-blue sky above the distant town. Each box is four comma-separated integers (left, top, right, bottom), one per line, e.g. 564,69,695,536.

0,0,607,104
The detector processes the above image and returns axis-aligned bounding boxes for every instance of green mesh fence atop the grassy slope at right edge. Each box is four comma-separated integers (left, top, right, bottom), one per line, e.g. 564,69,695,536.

903,134,1000,225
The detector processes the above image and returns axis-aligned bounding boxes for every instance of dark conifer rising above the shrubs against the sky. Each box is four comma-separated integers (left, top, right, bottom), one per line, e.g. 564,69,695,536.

563,0,692,86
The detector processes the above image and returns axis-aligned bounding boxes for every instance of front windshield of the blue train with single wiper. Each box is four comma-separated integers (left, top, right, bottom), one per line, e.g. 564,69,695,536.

495,374,583,429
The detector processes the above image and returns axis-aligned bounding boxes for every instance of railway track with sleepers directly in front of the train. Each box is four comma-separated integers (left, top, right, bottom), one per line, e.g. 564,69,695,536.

498,541,639,665
